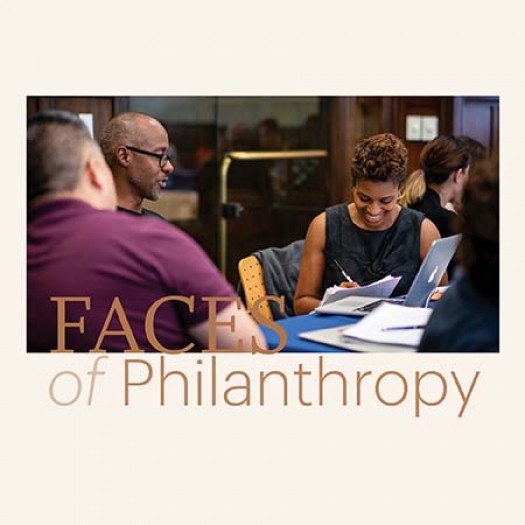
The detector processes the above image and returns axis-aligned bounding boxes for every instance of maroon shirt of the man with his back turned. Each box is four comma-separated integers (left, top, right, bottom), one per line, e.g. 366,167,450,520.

27,199,236,351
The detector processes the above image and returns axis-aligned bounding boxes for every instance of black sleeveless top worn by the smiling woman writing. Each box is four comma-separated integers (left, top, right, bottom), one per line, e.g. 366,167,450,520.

323,203,425,295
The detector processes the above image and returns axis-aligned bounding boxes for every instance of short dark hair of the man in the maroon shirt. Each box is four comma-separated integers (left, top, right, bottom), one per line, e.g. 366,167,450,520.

27,111,93,202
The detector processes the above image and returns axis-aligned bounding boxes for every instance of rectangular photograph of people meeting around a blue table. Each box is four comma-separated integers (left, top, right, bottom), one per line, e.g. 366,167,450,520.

27,95,499,354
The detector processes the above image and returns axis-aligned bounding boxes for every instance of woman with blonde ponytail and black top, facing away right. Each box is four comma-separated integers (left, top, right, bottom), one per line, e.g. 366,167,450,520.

399,135,470,237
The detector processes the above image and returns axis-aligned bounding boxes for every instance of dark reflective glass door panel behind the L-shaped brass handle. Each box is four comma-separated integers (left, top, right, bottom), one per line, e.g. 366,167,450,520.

129,96,328,276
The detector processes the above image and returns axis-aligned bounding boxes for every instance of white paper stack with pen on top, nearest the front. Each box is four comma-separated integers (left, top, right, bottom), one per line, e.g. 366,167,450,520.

343,303,432,346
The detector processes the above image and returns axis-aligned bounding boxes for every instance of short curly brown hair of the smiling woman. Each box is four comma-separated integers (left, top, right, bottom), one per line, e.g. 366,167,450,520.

351,133,408,186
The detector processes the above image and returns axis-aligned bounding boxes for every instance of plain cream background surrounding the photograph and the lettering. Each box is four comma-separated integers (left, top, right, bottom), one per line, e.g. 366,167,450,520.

0,0,525,525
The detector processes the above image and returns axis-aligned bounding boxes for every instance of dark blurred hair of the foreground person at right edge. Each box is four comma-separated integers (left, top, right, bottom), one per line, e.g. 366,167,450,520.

459,158,499,298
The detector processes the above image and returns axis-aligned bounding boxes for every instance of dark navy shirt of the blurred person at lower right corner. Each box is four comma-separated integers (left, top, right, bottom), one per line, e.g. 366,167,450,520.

419,277,499,352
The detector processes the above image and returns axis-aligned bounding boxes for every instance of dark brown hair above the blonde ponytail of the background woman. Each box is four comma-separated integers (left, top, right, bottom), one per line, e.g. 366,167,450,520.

420,135,470,185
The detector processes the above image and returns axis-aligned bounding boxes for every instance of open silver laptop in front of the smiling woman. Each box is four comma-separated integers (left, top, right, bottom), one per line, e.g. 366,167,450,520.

315,234,461,316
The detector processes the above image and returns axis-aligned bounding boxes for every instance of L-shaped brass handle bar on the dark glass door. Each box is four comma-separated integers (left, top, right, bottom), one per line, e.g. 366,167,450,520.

218,150,328,275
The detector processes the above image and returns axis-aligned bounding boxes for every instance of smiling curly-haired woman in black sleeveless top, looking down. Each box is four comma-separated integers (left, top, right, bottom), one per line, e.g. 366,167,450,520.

294,133,440,314
